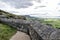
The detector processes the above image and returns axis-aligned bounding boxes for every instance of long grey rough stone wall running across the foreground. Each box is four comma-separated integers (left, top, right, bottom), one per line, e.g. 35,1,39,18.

0,18,60,40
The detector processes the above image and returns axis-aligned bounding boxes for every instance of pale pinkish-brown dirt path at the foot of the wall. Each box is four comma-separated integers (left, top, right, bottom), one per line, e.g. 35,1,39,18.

10,31,30,40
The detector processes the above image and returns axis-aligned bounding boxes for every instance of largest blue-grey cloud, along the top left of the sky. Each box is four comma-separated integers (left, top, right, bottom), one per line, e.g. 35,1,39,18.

0,0,33,8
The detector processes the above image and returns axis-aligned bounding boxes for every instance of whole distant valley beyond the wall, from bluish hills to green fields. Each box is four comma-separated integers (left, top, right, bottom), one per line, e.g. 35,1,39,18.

26,17,60,29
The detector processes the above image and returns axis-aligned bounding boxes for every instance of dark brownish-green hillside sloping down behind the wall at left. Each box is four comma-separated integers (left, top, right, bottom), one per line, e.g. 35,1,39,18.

0,10,26,20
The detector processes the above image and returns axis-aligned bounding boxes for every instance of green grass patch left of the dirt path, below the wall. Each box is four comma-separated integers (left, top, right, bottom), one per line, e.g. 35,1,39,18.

0,23,17,40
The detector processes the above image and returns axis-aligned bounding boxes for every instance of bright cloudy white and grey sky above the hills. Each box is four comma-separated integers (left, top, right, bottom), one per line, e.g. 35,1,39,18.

0,0,60,18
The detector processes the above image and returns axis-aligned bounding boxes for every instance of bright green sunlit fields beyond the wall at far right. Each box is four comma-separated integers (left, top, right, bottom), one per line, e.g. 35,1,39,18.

42,19,60,29
